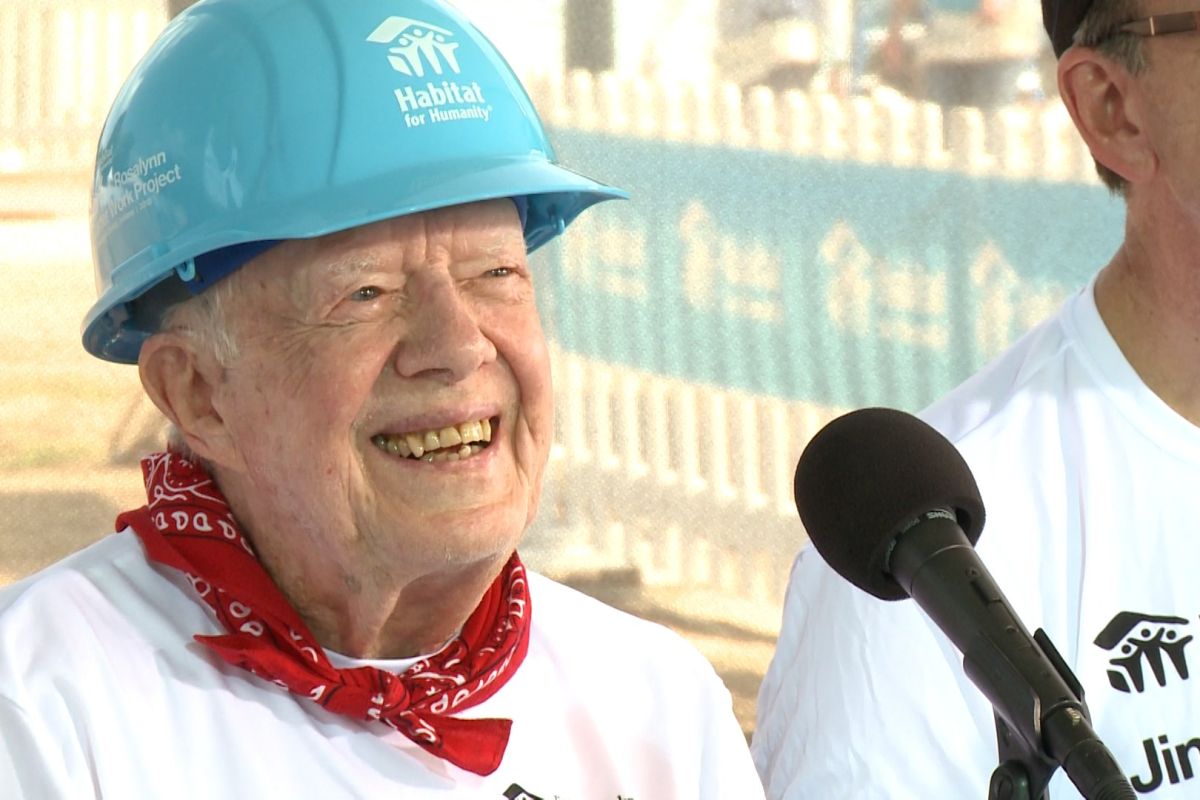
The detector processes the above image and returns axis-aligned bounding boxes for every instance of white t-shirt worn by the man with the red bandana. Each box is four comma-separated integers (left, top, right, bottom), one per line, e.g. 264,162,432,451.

0,531,762,800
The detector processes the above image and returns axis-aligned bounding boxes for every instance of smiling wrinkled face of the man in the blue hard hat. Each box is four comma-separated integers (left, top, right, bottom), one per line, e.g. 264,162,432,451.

205,200,553,579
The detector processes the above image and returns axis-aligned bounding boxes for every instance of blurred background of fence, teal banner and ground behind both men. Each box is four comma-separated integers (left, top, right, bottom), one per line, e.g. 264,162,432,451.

0,0,1122,733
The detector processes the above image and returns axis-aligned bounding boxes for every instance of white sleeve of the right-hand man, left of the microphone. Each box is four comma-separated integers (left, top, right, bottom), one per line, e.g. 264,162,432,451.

752,546,990,798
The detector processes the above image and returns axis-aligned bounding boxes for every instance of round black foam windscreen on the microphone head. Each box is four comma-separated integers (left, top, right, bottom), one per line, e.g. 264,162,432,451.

794,408,984,600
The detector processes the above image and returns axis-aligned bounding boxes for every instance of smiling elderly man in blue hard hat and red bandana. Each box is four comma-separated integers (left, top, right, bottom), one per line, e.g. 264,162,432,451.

0,0,762,800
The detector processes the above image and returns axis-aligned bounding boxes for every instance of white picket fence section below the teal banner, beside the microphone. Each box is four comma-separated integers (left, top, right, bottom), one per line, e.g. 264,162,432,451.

530,349,845,622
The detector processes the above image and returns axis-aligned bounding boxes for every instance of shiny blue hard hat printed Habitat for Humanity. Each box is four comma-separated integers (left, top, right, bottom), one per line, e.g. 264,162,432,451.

83,0,626,363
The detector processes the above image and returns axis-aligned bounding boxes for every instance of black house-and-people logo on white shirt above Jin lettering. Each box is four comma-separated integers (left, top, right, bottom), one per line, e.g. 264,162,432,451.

1094,612,1193,694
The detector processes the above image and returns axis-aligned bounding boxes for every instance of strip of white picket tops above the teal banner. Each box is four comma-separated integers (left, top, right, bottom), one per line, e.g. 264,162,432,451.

526,72,1096,182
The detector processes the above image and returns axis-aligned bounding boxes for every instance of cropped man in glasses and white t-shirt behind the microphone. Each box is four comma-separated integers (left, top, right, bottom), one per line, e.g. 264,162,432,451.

754,0,1200,800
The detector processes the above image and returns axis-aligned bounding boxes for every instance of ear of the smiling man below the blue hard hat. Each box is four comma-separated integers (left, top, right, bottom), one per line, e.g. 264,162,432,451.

138,331,239,467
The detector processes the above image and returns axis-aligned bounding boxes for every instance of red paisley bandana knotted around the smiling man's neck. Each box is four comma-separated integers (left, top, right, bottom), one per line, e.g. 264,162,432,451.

116,452,530,775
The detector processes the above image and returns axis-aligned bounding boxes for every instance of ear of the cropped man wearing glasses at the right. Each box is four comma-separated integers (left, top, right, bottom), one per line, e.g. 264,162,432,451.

1058,47,1158,184
